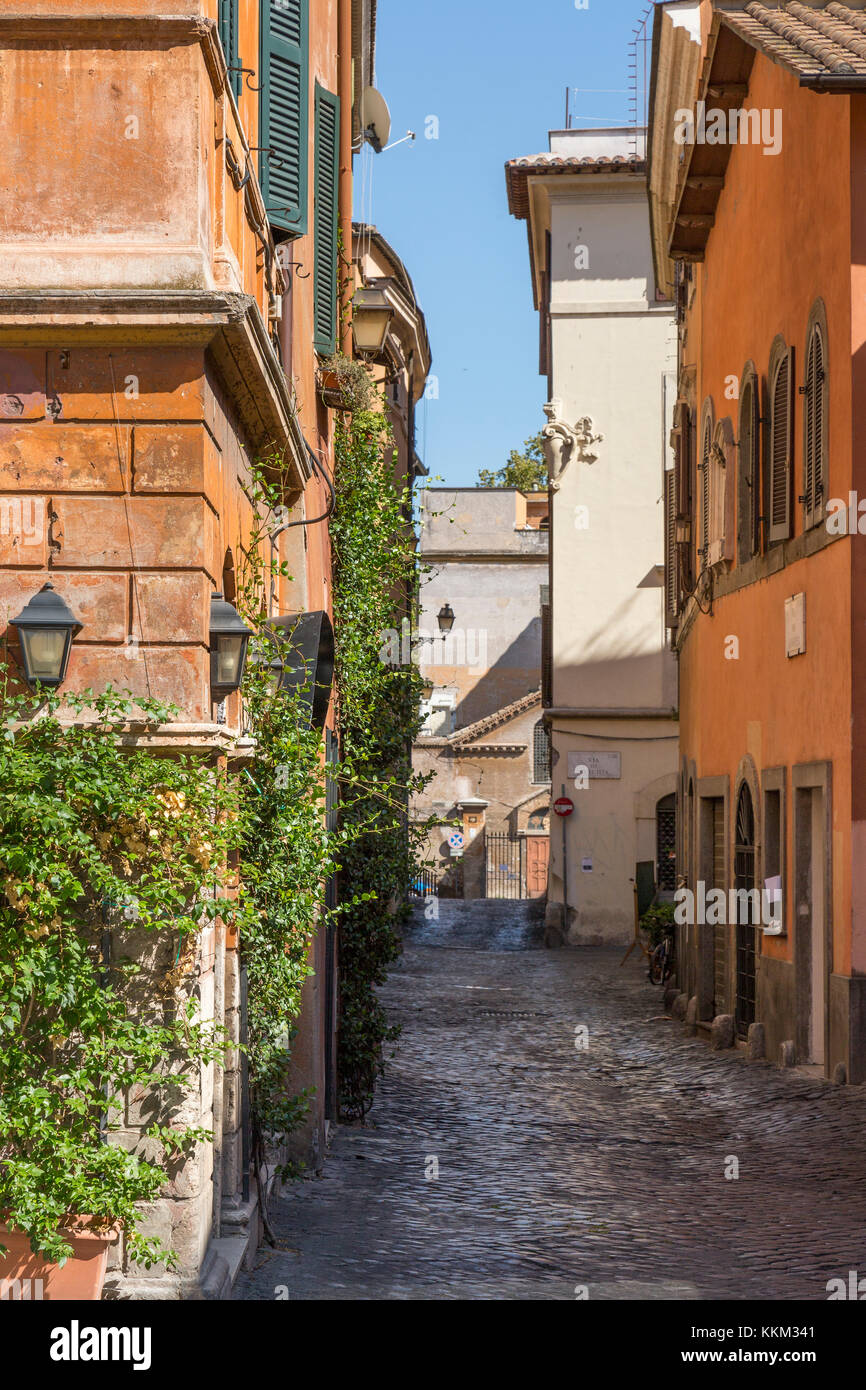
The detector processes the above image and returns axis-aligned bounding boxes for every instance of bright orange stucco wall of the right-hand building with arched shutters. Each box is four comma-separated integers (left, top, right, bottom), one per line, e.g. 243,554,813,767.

680,54,866,974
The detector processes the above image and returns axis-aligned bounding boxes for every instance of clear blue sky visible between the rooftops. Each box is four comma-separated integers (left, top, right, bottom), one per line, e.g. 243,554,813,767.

354,0,646,487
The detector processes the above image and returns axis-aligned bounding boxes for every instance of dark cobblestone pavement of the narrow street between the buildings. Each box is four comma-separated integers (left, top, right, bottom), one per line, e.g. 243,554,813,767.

236,906,866,1300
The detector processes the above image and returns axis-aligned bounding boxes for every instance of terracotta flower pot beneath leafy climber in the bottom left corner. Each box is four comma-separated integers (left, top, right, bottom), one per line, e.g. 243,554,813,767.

0,1216,120,1302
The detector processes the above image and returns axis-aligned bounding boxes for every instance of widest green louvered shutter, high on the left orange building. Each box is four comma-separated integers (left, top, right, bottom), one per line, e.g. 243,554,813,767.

261,0,310,236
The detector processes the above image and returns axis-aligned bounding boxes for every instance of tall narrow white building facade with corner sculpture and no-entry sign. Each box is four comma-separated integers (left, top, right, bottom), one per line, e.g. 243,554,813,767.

506,129,678,945
